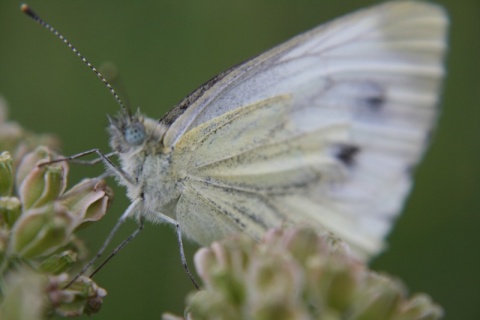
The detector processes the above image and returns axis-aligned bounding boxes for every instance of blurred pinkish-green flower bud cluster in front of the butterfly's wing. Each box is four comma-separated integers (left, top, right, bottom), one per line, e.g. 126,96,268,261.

164,228,443,320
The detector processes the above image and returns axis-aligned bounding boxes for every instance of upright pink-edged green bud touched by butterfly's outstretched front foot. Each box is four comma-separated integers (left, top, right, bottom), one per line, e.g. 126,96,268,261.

17,147,68,210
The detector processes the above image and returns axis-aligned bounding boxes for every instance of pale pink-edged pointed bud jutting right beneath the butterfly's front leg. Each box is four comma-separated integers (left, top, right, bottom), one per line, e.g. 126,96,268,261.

60,179,113,229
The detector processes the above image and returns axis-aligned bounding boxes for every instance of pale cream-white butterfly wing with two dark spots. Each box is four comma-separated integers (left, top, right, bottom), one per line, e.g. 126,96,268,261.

162,1,448,257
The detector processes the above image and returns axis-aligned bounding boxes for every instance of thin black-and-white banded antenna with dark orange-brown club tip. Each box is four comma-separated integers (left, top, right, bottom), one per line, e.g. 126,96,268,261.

20,4,130,115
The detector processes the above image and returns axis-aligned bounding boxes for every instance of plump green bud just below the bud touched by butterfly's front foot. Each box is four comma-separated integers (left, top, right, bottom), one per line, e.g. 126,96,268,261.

9,203,74,259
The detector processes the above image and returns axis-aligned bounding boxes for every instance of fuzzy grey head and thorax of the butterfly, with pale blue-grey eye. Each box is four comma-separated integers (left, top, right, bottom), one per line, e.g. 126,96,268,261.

109,113,180,220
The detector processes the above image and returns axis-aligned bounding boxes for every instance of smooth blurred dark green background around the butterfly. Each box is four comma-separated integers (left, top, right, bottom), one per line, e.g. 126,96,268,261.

0,0,480,319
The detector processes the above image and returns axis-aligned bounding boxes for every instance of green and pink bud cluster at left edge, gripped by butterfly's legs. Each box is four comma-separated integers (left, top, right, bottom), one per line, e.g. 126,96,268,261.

0,101,113,320
